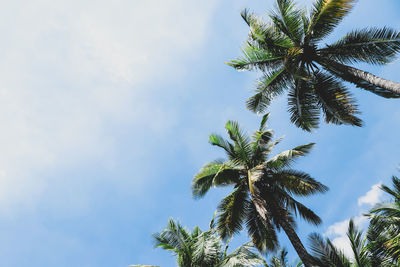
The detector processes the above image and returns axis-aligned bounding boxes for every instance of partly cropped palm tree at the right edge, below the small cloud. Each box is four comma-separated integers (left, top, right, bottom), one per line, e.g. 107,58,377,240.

368,176,400,262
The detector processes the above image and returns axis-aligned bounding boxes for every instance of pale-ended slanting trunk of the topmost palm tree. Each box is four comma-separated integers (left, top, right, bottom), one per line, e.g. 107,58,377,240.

316,57,400,96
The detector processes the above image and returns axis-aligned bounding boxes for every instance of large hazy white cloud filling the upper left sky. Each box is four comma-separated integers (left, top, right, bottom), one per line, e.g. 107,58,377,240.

0,0,222,214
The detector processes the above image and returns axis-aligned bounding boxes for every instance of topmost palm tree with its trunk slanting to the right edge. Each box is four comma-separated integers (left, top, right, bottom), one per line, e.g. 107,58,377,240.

228,0,400,131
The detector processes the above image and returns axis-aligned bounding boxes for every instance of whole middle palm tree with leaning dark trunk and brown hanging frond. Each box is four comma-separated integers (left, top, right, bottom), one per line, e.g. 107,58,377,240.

192,114,327,266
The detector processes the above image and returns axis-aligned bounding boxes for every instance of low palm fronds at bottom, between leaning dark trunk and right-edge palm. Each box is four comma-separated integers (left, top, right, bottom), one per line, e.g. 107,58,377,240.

310,219,396,267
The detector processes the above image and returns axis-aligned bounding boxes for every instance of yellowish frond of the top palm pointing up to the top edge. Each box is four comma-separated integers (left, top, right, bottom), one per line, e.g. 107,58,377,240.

306,0,356,42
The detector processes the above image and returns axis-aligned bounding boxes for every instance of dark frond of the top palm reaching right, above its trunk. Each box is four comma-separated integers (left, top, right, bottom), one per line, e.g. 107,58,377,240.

318,27,400,64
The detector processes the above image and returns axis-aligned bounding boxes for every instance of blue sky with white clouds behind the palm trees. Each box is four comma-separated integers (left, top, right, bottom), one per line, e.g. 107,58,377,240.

0,0,400,267
